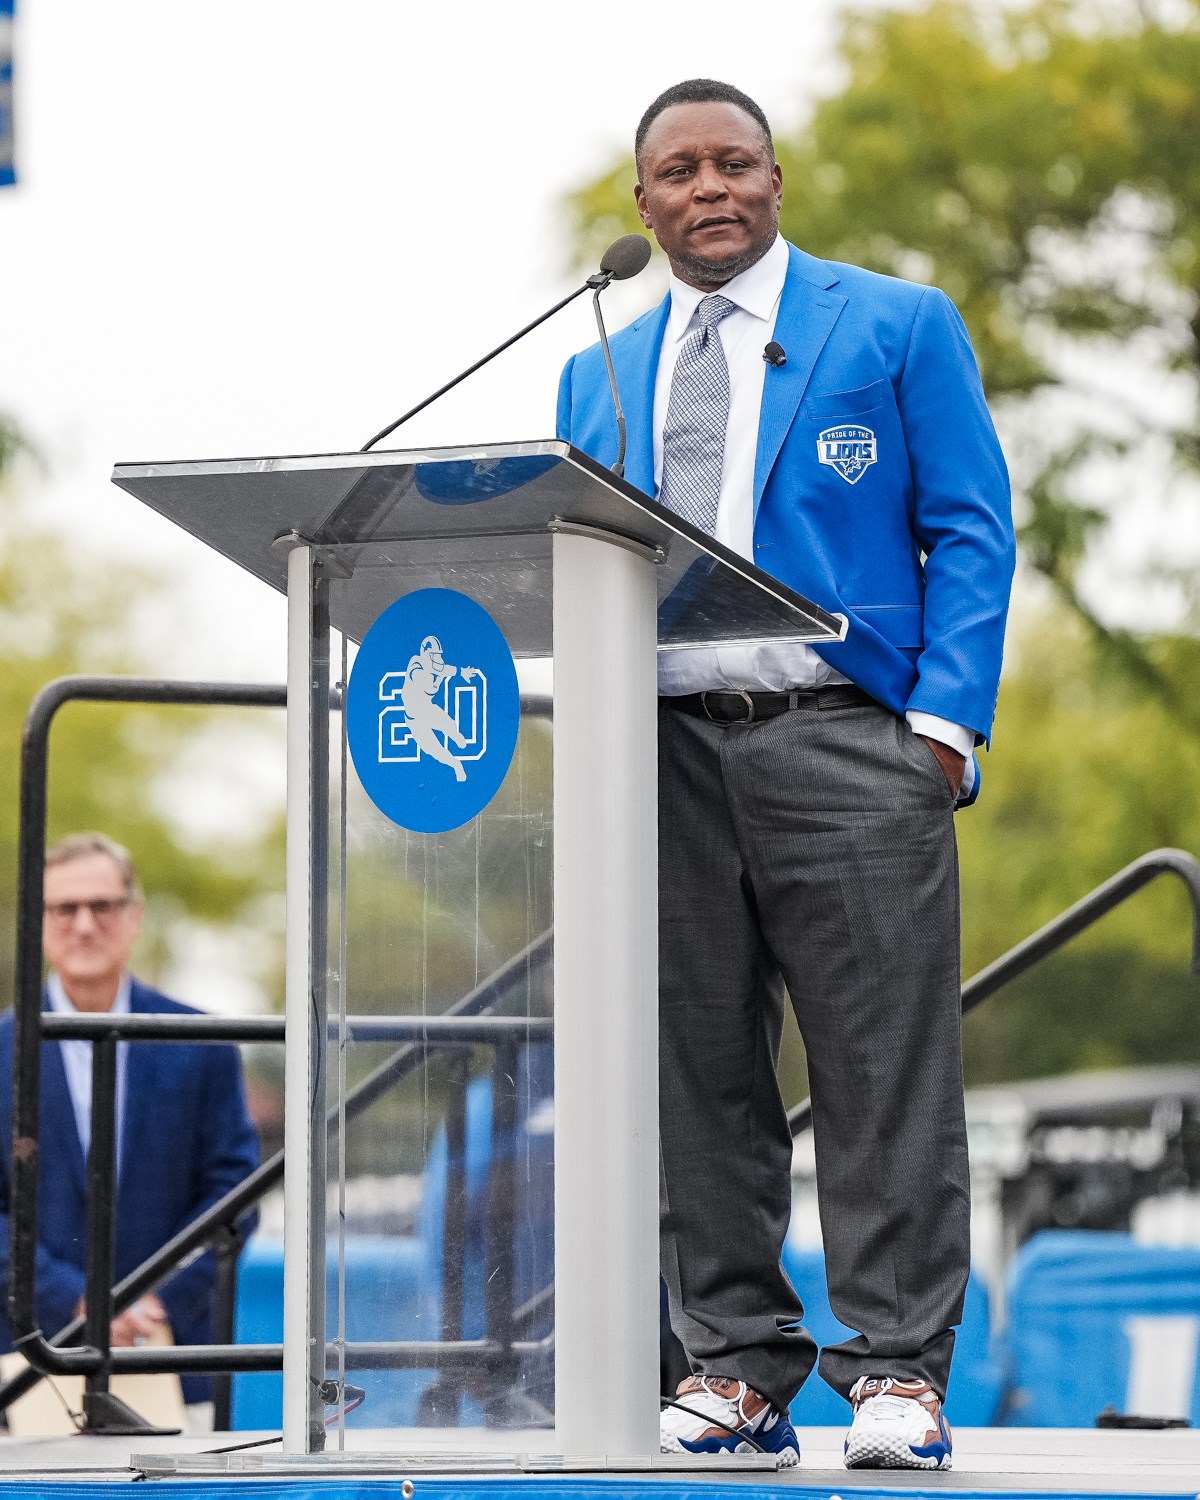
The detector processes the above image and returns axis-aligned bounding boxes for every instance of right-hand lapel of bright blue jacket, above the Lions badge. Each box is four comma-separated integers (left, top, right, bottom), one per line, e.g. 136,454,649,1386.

755,245,846,516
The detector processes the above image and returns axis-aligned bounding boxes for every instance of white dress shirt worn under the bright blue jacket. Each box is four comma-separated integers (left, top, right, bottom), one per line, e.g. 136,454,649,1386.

654,236,975,794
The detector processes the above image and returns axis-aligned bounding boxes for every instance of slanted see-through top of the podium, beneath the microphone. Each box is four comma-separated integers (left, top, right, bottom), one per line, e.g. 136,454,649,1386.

113,441,846,656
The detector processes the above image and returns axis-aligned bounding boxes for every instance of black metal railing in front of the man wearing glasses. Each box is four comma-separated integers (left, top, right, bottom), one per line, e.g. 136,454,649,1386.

0,677,552,1431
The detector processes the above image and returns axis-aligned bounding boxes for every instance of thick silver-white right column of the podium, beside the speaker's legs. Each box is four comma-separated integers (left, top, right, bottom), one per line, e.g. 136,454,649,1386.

554,528,659,1457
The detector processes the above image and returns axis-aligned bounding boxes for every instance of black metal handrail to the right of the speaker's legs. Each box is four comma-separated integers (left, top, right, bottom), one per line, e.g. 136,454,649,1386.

788,849,1200,1139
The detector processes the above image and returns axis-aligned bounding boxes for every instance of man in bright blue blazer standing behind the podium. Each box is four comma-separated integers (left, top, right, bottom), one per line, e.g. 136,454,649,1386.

558,80,1014,1469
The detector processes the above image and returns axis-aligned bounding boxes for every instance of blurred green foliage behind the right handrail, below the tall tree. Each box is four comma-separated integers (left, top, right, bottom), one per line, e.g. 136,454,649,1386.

957,611,1200,1083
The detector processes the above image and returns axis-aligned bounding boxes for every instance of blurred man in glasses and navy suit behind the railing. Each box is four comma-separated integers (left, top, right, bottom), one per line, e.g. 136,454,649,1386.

0,834,258,1425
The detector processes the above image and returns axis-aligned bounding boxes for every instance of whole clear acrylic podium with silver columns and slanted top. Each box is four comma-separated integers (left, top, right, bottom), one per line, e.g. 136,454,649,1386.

114,441,846,1460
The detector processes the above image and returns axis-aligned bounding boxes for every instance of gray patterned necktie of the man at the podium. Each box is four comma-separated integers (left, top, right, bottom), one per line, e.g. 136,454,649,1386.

659,297,737,536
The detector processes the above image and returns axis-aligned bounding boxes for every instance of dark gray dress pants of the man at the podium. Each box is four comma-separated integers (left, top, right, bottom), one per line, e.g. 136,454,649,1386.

659,699,969,1409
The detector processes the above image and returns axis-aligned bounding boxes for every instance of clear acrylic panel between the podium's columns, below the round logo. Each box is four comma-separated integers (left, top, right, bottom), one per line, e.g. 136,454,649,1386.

324,603,554,1451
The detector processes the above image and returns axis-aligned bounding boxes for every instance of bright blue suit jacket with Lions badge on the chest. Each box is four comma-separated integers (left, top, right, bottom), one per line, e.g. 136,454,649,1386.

558,246,1016,768
